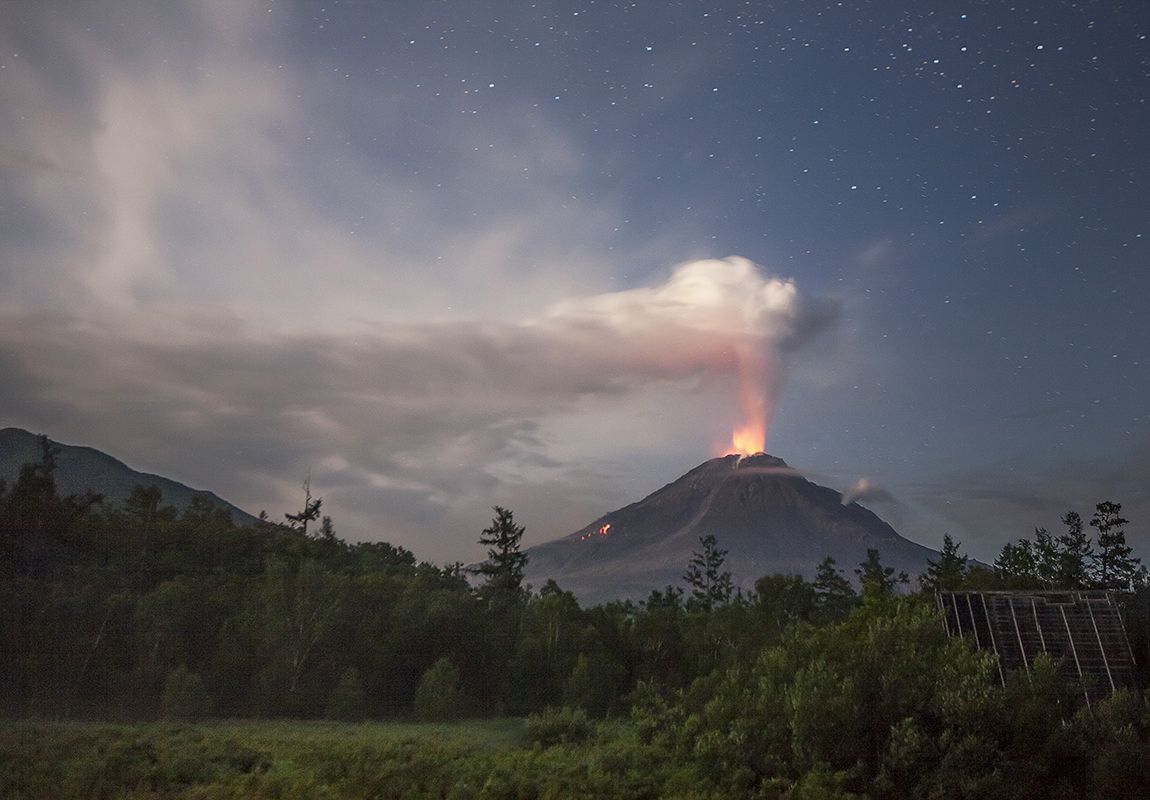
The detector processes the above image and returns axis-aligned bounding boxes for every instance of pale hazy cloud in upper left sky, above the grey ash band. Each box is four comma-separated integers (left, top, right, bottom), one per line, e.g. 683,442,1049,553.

0,0,667,331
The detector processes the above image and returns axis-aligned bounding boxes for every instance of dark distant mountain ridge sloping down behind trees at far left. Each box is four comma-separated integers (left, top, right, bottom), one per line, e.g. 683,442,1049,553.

0,428,259,525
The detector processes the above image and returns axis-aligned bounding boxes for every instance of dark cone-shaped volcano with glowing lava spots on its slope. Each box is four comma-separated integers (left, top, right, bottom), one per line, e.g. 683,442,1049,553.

528,453,937,602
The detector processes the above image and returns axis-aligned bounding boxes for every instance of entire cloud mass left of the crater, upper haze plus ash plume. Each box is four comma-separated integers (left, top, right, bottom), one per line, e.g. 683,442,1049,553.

0,0,836,560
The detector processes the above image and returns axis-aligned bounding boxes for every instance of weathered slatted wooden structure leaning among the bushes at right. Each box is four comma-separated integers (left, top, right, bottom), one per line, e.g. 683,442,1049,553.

935,591,1137,706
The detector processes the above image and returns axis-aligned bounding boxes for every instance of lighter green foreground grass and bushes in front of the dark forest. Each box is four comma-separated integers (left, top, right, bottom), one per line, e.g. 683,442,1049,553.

0,598,1150,800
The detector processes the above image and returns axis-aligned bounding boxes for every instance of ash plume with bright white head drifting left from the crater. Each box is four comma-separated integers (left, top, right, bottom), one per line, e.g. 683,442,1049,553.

0,257,841,558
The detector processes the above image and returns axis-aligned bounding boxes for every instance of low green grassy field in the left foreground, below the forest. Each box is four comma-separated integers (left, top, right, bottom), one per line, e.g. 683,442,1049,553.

0,720,660,800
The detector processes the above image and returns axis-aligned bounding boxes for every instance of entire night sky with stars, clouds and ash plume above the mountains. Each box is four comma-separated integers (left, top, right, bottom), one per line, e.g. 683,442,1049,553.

0,0,1150,562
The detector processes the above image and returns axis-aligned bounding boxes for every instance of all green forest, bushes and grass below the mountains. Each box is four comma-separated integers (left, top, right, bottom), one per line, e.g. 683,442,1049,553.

0,441,1150,798
